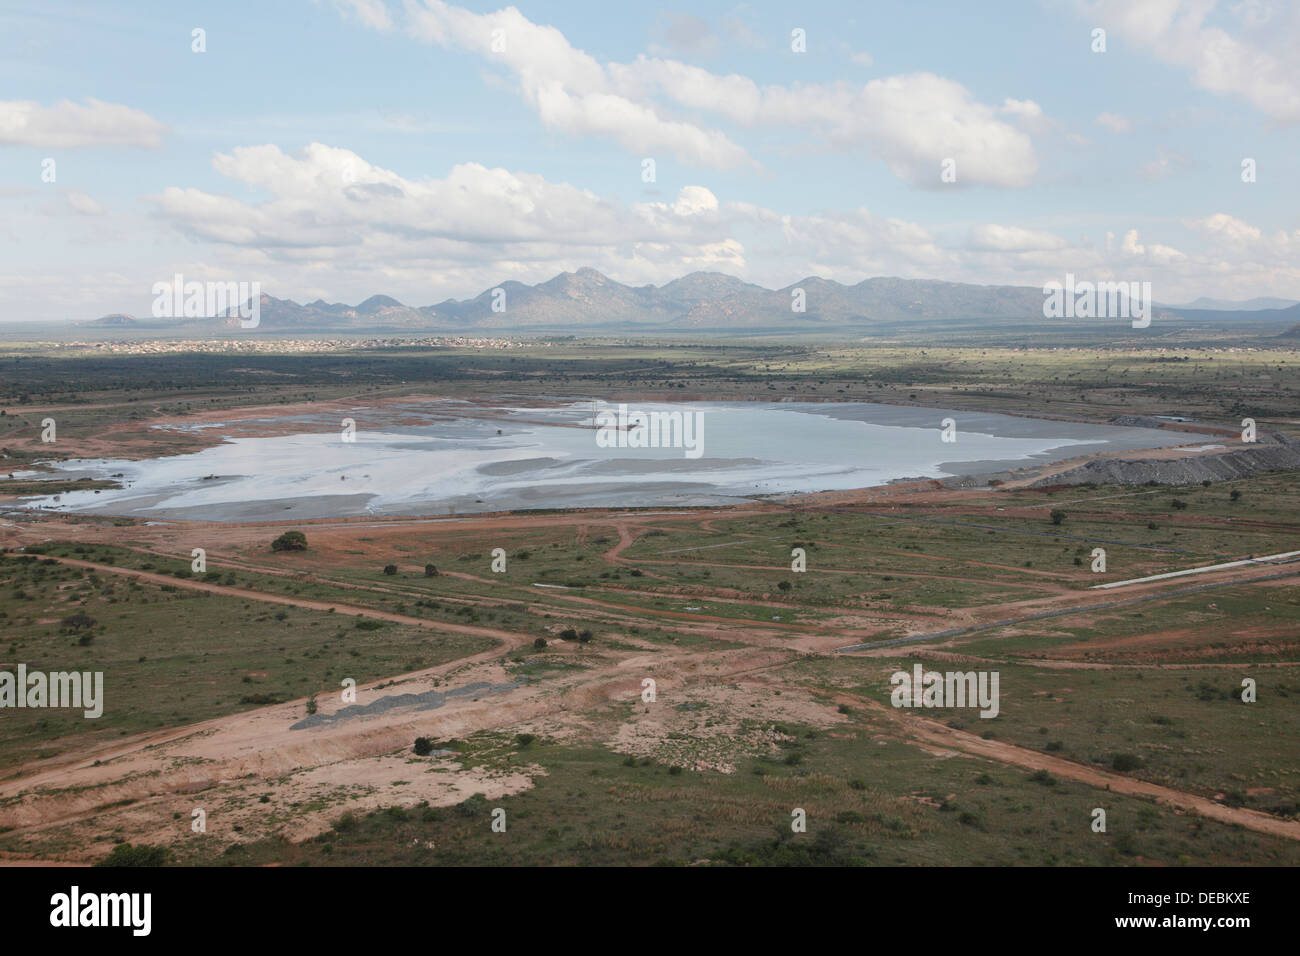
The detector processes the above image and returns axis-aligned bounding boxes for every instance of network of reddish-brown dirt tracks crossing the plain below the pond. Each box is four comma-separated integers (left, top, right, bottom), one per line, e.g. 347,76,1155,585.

0,399,1300,865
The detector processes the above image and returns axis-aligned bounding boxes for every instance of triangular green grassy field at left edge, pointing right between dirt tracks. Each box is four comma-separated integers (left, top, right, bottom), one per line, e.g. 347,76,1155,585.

0,555,494,771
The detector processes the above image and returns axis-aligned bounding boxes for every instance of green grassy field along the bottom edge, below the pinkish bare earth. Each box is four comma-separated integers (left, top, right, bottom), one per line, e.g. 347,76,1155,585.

178,722,1300,866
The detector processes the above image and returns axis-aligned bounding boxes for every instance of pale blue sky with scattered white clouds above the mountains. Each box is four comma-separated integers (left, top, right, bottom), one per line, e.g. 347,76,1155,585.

0,0,1300,321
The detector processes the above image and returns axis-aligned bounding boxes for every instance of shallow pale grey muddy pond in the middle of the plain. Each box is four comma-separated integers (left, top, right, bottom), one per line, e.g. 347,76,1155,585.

12,401,1187,522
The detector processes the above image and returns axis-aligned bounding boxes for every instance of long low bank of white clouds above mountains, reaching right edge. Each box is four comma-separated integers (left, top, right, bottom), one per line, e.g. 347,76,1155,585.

139,143,1300,304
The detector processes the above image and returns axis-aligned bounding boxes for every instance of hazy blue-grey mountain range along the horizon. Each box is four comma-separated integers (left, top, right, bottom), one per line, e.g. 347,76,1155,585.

87,269,1300,333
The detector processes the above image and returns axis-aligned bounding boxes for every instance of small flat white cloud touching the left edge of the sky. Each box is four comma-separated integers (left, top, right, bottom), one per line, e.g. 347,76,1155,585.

0,98,166,150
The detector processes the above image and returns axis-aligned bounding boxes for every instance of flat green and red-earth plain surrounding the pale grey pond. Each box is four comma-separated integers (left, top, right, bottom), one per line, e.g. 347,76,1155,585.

0,330,1300,865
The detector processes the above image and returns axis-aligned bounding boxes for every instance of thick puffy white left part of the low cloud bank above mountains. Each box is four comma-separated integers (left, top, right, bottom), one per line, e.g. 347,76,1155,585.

150,143,744,283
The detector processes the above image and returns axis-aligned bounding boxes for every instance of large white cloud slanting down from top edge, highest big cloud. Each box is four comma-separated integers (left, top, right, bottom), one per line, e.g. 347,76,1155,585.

382,0,1044,186
